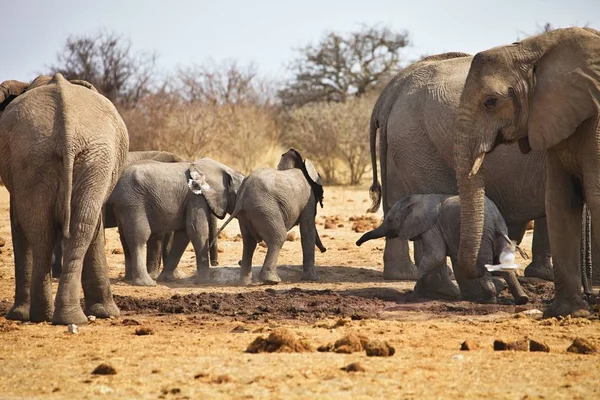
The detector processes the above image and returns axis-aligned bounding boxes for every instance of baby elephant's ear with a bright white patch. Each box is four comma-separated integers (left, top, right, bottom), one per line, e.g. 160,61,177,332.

186,160,232,219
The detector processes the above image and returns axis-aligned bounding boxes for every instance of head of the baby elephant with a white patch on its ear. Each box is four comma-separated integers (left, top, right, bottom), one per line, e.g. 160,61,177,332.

186,158,244,219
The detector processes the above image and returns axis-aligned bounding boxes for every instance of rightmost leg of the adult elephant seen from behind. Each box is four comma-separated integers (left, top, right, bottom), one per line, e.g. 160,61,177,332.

81,218,119,318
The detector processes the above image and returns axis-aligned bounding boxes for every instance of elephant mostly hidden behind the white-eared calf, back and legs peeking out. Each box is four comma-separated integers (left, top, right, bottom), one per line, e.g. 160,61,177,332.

52,151,188,280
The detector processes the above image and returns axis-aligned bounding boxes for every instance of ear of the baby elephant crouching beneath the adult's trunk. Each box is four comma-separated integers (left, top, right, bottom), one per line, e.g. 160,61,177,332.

390,195,442,240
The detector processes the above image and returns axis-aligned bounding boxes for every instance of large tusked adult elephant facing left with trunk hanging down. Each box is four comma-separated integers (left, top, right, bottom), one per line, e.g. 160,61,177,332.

454,28,600,316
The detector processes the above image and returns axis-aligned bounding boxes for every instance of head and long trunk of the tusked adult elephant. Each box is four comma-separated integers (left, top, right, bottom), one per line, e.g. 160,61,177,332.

454,28,600,279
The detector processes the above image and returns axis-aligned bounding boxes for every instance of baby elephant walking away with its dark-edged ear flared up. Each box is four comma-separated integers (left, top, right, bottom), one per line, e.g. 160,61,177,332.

217,149,326,284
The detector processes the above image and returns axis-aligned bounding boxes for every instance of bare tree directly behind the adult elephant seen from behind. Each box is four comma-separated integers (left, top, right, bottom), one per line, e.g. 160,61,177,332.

49,31,156,108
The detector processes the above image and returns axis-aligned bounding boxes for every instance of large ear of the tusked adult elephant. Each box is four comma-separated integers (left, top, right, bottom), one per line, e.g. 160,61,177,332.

527,28,600,150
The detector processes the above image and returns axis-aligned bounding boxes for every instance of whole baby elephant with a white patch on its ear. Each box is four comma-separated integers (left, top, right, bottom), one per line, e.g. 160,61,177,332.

107,158,244,286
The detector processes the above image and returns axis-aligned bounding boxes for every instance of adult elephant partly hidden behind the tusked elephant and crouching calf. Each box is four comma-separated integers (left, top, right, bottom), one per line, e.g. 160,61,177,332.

369,53,553,280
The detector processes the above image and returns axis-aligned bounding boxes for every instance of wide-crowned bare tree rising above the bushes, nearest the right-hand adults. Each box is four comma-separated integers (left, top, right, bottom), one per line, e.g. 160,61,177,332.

279,26,409,106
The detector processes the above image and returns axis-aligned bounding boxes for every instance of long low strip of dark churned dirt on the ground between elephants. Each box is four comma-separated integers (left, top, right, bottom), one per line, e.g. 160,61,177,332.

114,288,386,321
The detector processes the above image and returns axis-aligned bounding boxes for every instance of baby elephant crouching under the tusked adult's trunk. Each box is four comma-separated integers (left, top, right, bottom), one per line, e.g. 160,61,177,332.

356,194,528,304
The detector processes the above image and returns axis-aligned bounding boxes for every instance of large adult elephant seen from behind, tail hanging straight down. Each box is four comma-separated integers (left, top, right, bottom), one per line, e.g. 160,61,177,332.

0,74,129,324
